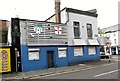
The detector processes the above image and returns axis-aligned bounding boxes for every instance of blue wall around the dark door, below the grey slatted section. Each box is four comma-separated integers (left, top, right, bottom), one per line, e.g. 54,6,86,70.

21,45,68,71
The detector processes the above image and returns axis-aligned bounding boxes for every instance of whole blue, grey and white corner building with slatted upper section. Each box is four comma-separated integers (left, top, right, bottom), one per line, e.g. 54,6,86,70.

8,8,100,71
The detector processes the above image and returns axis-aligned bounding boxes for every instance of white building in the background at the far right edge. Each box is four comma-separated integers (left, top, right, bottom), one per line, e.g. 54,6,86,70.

100,24,120,55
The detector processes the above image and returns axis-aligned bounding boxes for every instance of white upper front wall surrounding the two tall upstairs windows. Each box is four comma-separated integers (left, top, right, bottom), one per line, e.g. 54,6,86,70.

67,12,98,44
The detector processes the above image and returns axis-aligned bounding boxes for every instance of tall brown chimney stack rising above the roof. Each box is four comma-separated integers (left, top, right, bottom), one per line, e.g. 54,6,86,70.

55,0,61,23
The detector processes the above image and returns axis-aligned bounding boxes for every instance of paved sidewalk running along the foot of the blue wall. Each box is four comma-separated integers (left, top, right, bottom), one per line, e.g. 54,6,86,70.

2,60,115,80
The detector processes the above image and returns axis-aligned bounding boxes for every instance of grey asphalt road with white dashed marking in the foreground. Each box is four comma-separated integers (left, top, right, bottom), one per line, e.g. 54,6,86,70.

32,55,120,79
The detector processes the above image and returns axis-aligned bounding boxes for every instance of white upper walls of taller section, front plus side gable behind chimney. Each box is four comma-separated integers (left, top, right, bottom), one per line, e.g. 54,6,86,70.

47,9,98,45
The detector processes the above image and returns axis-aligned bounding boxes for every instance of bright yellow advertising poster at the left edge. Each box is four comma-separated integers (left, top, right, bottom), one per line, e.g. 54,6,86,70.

0,48,11,73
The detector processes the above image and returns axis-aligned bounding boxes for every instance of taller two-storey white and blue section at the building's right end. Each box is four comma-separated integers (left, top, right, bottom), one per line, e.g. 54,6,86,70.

46,8,99,63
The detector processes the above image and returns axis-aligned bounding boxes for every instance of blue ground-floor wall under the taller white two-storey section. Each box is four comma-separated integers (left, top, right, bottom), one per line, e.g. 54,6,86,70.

68,46,100,64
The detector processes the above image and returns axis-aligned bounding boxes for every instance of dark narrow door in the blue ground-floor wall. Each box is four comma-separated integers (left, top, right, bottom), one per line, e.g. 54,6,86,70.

47,51,54,68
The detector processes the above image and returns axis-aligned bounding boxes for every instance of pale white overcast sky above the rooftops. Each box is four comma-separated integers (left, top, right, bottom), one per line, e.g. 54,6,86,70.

0,0,120,28
